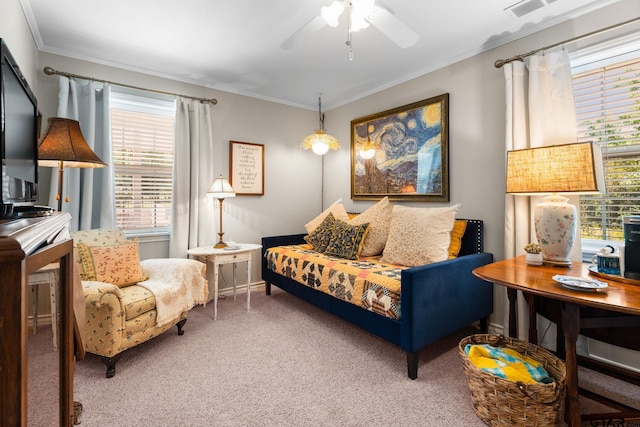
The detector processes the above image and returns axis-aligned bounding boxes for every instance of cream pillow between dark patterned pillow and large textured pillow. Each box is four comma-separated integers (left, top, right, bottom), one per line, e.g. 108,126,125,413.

349,197,393,256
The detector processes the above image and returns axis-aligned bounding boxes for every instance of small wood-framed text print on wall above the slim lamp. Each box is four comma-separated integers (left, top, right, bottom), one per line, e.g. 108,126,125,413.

229,141,264,196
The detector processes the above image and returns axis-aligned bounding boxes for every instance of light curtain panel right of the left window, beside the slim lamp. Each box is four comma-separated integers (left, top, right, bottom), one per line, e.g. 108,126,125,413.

169,98,217,258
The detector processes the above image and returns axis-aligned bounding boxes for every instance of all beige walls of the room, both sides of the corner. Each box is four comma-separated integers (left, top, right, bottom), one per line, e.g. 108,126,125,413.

7,0,640,325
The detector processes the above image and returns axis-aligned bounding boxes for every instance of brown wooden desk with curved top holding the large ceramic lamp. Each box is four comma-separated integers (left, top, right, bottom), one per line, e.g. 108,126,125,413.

473,256,640,427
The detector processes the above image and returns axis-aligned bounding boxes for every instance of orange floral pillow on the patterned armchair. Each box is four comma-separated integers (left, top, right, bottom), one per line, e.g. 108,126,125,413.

78,239,147,287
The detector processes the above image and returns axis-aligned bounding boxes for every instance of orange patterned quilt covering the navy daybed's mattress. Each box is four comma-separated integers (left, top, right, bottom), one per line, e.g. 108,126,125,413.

265,244,408,319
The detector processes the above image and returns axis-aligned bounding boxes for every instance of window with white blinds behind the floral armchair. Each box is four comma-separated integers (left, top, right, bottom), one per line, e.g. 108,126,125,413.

110,88,175,233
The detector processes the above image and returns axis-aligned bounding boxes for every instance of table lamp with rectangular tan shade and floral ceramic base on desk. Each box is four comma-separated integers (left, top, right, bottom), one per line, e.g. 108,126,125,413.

507,142,605,267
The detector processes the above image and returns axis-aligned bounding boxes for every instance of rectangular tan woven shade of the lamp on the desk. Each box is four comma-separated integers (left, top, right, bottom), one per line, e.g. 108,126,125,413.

507,142,605,195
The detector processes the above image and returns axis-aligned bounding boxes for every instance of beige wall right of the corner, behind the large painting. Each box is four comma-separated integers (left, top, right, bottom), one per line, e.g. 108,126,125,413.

324,0,640,325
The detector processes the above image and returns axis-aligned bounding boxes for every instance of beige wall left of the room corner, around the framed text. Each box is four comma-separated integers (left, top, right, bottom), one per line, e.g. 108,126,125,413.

38,53,322,295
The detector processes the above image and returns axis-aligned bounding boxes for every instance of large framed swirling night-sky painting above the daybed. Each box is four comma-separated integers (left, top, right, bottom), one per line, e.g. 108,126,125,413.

351,93,449,202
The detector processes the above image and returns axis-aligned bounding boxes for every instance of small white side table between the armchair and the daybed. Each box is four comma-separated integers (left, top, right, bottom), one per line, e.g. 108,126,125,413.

187,243,262,320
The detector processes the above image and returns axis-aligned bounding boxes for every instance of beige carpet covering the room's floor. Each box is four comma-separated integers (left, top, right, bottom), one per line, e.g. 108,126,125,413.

28,288,640,427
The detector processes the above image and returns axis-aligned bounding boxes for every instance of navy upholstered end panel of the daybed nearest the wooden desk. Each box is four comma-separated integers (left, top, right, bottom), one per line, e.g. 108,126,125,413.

400,252,493,352
